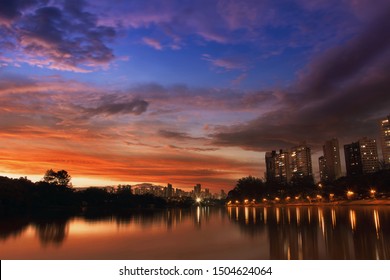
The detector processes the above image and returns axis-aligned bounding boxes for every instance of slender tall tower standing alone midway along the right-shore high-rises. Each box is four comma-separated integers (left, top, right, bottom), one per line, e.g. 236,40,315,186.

322,138,341,181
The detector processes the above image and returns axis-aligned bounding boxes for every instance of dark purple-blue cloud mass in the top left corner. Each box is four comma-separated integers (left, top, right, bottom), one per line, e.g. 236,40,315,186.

0,1,116,72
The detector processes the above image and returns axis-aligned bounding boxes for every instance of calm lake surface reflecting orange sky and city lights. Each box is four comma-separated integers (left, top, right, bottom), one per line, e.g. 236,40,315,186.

0,206,390,259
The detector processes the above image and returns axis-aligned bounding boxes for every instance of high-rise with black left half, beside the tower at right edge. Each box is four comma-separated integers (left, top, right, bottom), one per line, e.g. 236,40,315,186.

344,137,379,176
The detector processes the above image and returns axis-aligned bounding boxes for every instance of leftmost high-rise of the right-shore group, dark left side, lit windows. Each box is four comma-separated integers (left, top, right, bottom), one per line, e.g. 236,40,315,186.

265,150,291,184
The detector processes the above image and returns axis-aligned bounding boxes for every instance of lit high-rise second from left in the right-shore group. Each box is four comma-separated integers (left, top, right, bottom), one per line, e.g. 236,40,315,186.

290,144,313,178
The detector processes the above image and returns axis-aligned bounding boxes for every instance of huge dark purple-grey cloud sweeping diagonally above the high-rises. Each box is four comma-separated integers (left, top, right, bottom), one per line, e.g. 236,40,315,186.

210,3,390,151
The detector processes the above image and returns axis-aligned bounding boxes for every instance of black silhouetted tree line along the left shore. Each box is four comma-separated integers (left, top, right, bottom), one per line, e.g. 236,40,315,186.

0,169,167,214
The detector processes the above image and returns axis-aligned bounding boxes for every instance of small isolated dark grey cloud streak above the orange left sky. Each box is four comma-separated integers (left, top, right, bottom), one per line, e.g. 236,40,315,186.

86,99,149,115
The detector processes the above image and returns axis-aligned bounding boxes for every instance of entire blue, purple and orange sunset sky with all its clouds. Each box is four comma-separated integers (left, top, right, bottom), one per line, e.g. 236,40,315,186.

0,0,390,191
